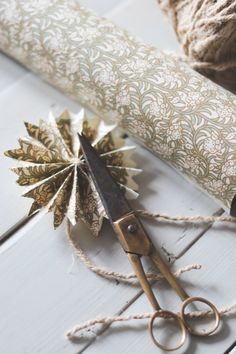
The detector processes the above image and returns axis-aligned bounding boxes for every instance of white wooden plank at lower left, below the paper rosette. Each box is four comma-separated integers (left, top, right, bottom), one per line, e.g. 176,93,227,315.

0,215,146,354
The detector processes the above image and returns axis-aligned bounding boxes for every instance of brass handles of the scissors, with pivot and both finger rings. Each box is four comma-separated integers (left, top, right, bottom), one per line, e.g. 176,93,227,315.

114,212,220,351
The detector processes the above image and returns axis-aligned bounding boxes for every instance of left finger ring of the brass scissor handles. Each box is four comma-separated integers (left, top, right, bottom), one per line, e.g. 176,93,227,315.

149,310,187,352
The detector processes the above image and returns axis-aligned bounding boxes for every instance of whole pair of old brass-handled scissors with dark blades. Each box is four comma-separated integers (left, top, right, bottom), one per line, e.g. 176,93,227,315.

78,134,220,351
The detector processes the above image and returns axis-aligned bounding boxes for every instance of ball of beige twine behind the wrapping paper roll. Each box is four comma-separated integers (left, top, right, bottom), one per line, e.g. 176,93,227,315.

157,0,236,93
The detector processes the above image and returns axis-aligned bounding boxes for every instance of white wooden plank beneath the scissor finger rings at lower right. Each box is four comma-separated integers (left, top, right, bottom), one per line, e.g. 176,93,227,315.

84,220,236,354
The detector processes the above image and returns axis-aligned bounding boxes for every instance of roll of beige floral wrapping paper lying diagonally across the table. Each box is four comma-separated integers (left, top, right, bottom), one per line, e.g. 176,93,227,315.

0,0,236,210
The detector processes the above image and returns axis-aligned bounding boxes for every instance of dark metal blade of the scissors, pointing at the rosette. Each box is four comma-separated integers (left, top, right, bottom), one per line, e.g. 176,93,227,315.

78,134,132,222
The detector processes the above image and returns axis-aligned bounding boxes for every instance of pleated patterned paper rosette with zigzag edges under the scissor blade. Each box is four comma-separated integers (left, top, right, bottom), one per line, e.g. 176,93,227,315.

5,110,141,235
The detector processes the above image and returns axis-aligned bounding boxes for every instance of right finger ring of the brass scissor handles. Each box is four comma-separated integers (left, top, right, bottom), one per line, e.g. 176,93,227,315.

181,296,220,337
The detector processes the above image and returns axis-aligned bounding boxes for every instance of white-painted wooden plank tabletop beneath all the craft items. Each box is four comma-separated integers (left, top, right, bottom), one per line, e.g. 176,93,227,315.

0,0,236,354
